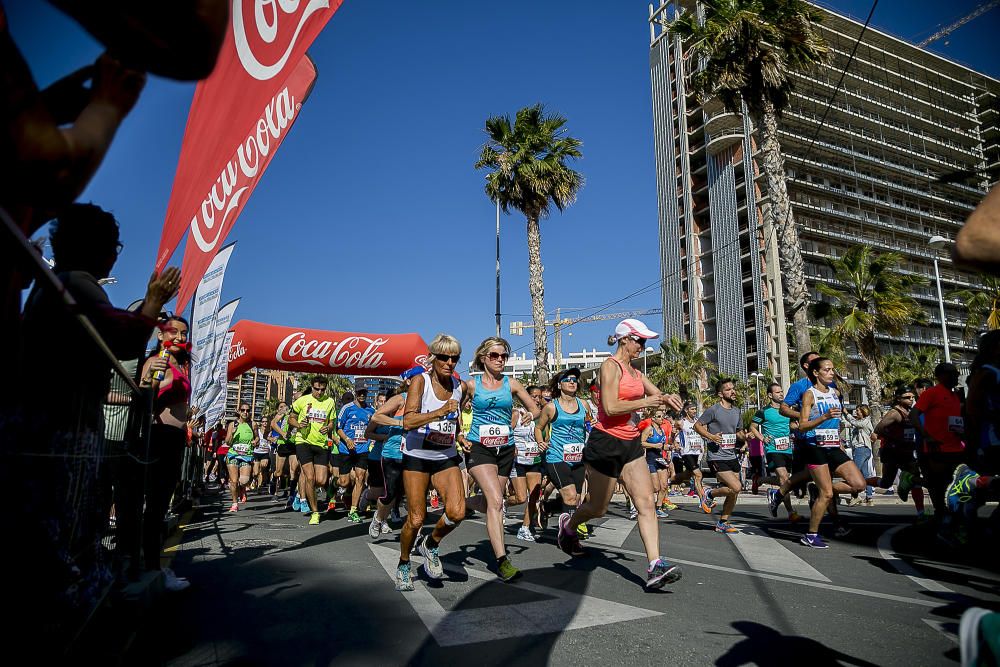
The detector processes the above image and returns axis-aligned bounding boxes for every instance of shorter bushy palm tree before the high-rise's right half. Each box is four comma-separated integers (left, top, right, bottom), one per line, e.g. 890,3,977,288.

813,245,927,421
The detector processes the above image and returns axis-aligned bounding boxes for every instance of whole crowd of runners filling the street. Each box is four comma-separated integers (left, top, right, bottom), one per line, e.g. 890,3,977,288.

178,319,1000,591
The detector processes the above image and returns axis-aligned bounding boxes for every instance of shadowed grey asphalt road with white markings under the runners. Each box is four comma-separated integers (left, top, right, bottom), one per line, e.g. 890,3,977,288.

139,488,1000,667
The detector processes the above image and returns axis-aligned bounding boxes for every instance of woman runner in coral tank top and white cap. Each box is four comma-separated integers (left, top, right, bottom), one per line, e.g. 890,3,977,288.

557,319,681,588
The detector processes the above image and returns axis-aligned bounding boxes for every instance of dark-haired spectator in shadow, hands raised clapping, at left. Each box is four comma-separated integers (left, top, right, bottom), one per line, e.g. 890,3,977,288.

10,204,180,640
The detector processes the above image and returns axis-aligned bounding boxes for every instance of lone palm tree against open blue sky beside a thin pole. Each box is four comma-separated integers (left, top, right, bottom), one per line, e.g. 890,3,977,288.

476,104,583,384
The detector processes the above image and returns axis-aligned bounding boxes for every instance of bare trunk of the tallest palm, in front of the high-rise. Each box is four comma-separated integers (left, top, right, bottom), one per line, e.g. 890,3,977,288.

757,100,810,355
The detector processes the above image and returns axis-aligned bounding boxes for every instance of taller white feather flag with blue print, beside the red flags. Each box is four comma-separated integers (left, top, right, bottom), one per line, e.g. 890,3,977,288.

190,243,236,405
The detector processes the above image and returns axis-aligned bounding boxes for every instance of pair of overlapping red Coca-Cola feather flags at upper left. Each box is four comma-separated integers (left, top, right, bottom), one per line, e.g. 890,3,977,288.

156,0,342,311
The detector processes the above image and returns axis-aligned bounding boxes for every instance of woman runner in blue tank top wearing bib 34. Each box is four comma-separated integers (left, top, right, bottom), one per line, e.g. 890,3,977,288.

535,368,592,514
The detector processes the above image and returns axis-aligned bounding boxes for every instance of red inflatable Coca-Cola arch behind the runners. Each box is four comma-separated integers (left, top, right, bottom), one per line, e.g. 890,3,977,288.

229,320,427,380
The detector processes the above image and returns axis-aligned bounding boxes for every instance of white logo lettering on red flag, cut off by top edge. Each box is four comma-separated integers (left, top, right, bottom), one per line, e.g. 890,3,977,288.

233,0,330,81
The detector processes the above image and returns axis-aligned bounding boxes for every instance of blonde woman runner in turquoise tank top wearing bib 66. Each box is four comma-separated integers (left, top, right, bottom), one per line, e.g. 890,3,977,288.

459,337,540,581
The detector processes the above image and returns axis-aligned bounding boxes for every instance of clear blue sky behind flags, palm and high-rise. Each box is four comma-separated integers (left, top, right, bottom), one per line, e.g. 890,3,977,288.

4,0,1000,376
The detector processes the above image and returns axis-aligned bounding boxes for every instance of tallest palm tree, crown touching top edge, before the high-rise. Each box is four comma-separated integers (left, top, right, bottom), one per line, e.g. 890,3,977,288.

669,0,830,362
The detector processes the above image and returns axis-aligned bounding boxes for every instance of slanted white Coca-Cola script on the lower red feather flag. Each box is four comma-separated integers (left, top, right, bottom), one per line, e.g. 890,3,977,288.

191,87,302,253
